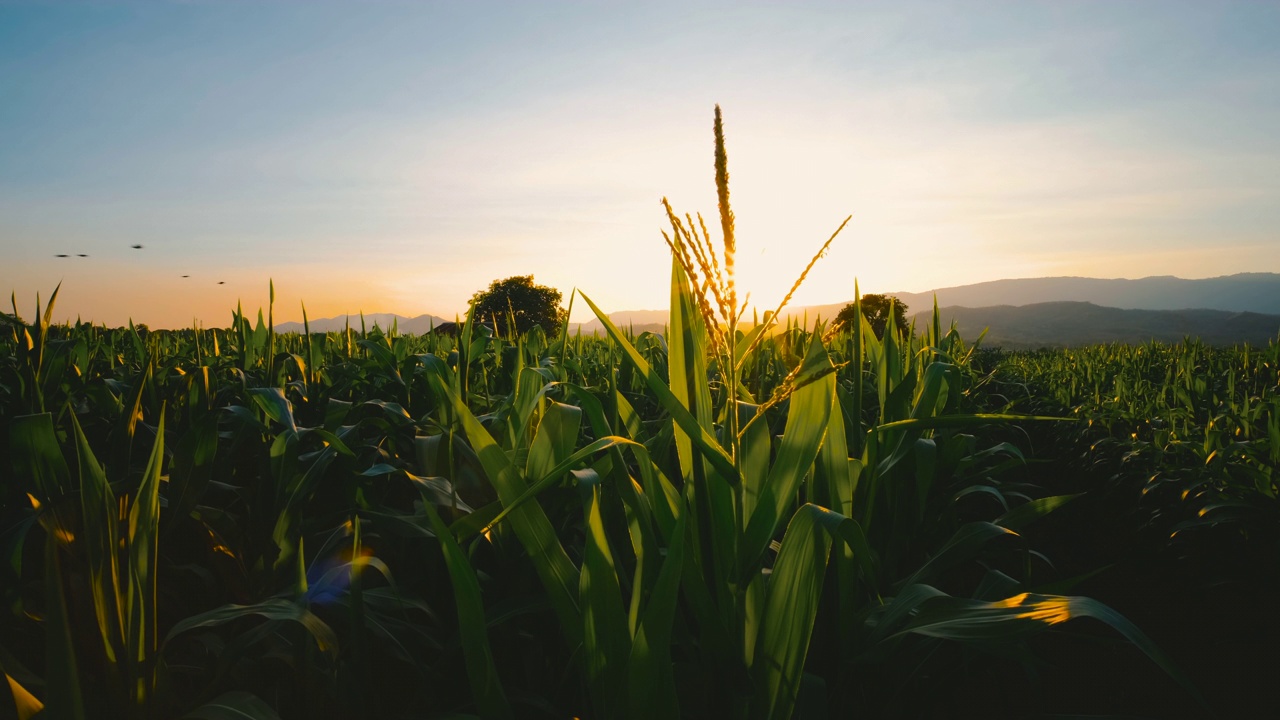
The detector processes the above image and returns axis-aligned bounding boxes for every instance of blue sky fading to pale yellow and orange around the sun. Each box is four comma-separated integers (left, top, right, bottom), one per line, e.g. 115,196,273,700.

0,0,1280,328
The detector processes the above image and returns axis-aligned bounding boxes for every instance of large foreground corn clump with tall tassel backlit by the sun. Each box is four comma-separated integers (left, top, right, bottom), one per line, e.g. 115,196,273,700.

391,107,1198,717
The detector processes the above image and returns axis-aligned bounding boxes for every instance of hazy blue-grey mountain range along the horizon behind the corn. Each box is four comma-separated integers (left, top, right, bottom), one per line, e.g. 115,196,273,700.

276,273,1280,347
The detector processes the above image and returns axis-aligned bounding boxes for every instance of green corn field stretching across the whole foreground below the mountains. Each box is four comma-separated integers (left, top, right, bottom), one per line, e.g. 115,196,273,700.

0,113,1280,719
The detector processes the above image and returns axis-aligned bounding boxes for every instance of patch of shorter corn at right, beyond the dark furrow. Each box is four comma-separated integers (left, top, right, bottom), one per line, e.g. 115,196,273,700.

997,340,1280,579
